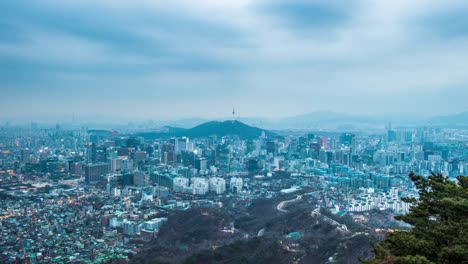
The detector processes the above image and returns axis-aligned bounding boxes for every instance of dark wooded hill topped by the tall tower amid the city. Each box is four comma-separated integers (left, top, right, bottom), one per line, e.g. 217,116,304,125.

137,121,277,139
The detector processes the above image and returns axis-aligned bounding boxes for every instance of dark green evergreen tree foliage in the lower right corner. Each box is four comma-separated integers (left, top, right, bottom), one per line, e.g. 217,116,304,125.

363,173,468,264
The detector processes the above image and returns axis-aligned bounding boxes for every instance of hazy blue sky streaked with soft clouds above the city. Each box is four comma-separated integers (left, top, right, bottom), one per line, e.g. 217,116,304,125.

0,0,468,119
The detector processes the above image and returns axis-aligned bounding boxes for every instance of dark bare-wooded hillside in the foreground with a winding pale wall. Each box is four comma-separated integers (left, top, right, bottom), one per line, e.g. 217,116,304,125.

132,197,373,264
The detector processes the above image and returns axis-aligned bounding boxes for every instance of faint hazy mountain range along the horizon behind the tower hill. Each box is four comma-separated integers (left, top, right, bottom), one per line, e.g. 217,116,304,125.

4,111,468,131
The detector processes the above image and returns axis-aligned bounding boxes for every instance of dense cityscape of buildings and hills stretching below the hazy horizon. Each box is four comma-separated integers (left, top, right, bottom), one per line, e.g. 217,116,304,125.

0,103,468,264
